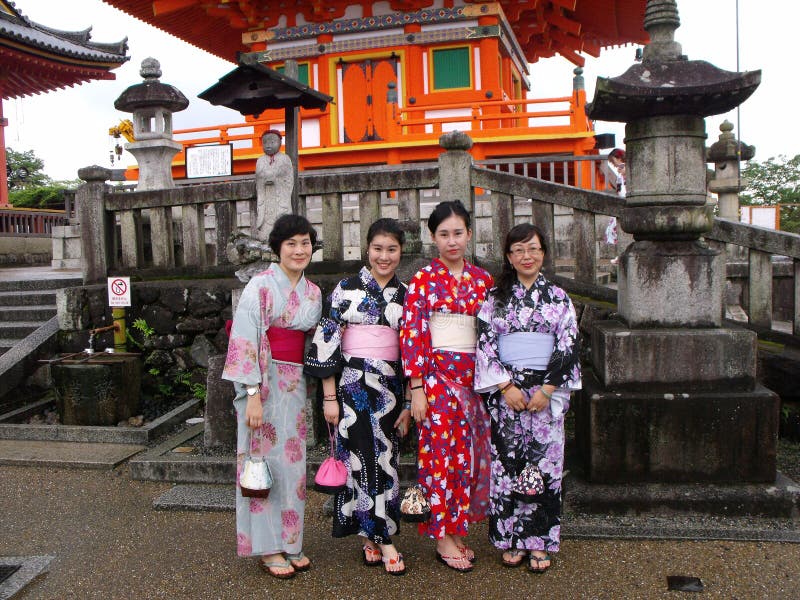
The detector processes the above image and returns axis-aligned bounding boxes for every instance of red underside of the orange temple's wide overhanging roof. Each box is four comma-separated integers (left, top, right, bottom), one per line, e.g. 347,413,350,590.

103,0,648,65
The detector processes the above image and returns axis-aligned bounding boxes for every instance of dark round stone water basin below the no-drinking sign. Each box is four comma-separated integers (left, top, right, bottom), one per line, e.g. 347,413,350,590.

50,352,142,425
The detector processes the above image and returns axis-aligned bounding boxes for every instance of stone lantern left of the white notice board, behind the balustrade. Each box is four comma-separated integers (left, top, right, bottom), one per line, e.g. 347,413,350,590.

114,58,189,191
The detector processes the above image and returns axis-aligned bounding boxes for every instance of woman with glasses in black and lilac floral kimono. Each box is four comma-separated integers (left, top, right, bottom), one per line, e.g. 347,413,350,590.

475,223,581,573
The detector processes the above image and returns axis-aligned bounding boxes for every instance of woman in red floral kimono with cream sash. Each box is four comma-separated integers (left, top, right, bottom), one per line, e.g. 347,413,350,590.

400,200,493,572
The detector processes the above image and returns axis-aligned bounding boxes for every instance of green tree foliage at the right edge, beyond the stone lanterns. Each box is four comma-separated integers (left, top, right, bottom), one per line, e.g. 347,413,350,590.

739,154,800,233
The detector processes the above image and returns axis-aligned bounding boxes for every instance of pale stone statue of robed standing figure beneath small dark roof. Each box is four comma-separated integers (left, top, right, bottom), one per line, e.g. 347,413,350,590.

255,129,294,241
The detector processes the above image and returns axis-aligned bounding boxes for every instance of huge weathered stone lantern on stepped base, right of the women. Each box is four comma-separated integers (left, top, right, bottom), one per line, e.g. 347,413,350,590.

576,0,779,496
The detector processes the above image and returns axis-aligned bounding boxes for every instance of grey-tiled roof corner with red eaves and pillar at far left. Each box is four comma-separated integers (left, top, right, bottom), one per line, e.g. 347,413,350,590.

0,0,130,206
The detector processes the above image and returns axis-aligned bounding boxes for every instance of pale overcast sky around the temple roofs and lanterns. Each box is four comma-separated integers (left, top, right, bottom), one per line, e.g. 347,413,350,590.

4,0,800,179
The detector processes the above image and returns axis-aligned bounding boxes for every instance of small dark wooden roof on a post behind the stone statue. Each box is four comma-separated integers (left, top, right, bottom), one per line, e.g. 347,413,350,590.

198,55,333,213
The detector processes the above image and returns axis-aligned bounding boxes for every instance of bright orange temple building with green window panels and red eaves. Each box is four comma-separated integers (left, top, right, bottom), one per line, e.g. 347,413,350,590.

104,0,647,178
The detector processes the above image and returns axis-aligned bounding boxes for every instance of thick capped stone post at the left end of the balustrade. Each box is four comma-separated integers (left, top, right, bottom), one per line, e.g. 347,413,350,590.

75,165,111,284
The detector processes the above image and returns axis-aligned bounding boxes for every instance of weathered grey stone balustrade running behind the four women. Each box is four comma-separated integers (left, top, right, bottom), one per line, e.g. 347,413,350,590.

77,143,800,336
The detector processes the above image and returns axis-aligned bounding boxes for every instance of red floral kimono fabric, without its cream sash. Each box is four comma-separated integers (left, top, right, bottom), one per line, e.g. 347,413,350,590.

400,258,494,539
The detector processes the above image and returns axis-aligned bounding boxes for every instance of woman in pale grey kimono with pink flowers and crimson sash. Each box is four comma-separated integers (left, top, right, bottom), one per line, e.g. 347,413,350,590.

222,215,322,579
